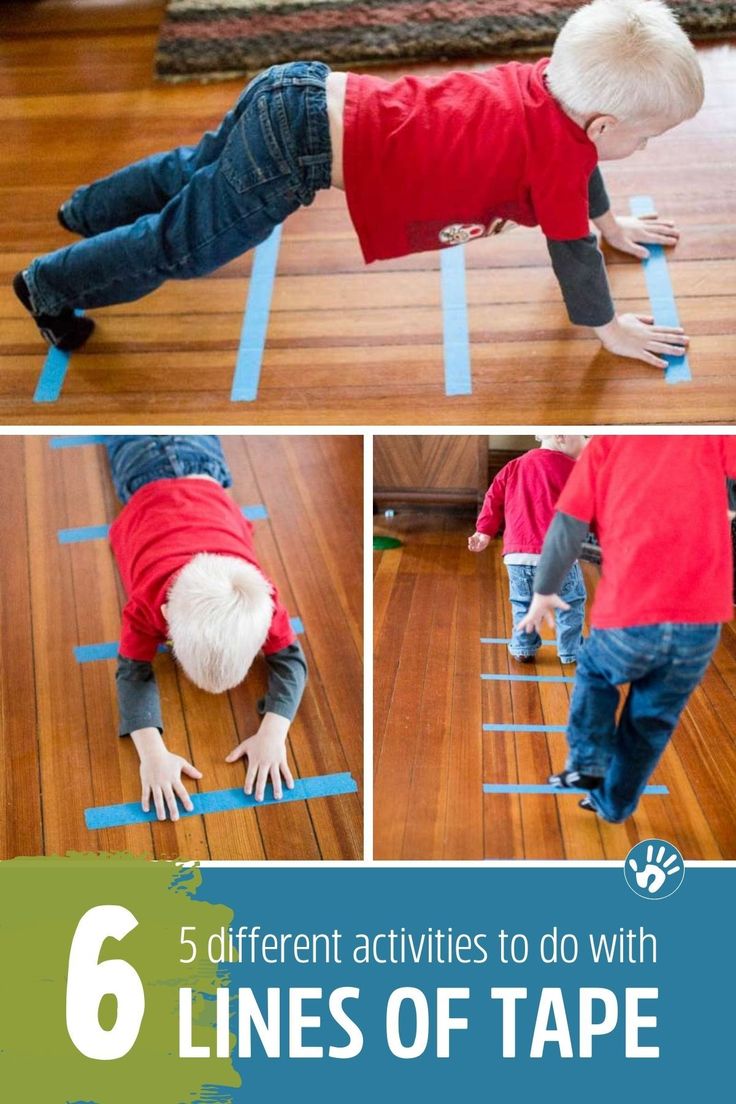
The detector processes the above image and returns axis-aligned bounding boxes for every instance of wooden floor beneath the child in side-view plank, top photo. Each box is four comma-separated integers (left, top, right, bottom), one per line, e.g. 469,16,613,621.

0,0,736,425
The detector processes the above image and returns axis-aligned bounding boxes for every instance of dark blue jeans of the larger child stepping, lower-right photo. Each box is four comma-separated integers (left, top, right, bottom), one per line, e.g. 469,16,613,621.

567,622,721,822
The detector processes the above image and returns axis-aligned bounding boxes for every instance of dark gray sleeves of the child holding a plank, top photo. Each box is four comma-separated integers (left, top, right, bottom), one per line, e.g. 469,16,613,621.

547,166,616,326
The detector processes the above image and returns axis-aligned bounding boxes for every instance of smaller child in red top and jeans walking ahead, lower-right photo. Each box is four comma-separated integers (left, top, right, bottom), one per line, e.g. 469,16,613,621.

468,434,586,664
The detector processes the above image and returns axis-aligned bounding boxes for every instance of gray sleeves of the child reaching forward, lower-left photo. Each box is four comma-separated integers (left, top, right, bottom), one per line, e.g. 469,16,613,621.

115,640,307,736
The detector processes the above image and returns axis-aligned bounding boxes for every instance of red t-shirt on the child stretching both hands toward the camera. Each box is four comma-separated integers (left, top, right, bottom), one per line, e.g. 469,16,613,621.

110,479,296,661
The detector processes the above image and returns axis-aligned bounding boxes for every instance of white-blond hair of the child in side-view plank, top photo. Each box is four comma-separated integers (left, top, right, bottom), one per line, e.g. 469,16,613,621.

546,0,704,125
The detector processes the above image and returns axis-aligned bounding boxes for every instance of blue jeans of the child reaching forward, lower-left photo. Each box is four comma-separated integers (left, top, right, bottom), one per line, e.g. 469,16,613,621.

105,434,233,503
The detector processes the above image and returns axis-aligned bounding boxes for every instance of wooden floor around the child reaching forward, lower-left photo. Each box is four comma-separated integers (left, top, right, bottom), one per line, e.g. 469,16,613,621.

0,436,363,859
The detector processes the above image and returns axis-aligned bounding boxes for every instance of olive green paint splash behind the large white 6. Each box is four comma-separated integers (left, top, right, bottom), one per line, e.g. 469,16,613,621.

0,854,241,1104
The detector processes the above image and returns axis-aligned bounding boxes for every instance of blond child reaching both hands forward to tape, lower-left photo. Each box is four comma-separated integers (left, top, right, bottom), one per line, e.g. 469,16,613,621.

107,436,307,820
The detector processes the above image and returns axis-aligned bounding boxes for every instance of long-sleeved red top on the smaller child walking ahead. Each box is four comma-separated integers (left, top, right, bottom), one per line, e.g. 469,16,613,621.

476,448,575,554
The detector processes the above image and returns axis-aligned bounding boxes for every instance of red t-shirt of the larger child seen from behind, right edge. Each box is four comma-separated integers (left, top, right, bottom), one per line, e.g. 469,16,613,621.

557,436,736,628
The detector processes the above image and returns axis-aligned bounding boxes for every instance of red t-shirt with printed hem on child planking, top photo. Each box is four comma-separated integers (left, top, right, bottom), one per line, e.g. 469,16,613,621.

343,59,598,262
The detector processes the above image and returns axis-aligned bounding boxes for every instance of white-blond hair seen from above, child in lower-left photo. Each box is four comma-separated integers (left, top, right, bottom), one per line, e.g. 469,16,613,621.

166,552,274,693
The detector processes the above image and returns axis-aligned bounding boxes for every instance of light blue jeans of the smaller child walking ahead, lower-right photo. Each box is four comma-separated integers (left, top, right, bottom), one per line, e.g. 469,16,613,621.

506,563,586,661
